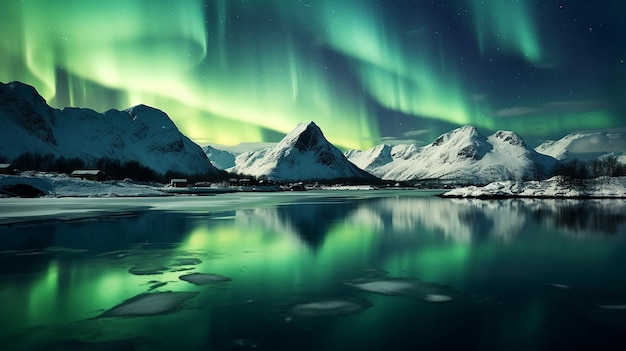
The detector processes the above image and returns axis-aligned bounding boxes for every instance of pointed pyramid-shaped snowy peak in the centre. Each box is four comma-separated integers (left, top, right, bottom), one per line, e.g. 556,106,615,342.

229,122,375,181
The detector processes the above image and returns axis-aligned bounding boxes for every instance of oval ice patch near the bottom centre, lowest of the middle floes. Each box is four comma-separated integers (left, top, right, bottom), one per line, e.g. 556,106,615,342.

287,298,373,318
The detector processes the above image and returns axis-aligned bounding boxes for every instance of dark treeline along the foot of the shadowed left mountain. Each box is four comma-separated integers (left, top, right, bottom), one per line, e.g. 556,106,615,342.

7,152,228,183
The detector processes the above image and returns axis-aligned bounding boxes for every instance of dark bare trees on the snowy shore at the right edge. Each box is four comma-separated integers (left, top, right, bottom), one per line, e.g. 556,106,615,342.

552,155,626,179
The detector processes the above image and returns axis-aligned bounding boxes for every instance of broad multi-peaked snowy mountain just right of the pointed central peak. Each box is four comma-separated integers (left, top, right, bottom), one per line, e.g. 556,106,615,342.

346,126,556,184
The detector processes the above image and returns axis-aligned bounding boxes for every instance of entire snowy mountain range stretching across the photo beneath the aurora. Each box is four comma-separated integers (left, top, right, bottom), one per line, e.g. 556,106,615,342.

0,82,626,184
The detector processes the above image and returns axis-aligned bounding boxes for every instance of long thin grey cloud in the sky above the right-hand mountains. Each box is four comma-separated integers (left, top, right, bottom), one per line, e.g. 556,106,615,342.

494,100,607,117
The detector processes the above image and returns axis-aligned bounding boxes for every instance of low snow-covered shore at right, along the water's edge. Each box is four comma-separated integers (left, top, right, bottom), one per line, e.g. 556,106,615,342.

441,177,626,198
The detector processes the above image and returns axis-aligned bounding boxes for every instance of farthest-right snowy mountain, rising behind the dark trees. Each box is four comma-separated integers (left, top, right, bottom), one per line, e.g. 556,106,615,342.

535,132,626,163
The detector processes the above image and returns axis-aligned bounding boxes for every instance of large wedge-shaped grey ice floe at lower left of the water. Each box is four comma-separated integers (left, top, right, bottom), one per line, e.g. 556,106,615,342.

99,291,198,318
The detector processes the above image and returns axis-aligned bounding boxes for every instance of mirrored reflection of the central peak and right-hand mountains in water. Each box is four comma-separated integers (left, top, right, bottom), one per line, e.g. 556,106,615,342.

238,197,626,247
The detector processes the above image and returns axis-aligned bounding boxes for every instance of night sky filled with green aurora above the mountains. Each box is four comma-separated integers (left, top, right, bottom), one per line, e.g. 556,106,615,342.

0,0,626,149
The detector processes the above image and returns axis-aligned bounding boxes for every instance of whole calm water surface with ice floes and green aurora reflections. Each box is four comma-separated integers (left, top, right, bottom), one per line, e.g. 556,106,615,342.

0,191,626,350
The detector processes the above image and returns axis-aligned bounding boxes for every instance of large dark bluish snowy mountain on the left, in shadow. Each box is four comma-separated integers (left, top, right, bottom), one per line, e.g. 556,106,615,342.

0,82,218,174
